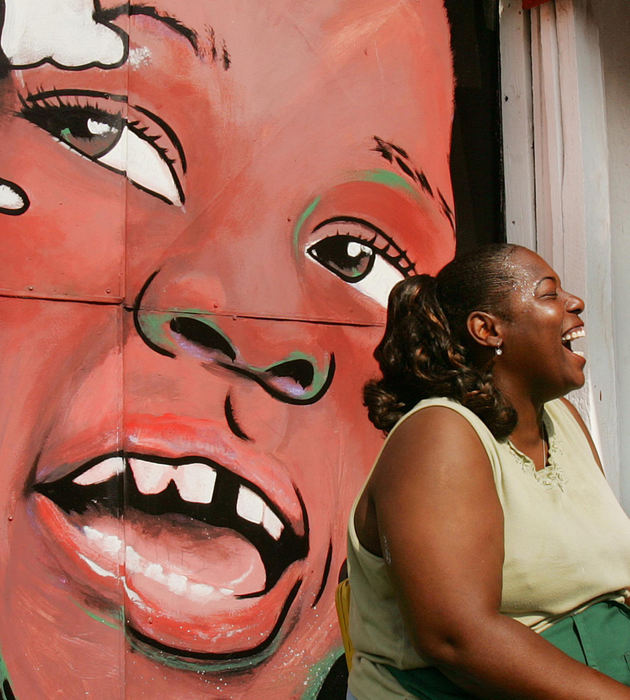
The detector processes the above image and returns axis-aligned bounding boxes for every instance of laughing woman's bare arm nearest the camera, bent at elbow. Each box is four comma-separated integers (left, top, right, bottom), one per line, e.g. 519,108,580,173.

368,407,630,700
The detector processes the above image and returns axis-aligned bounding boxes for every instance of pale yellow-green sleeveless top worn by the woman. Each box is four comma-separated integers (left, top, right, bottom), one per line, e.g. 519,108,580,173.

348,399,630,700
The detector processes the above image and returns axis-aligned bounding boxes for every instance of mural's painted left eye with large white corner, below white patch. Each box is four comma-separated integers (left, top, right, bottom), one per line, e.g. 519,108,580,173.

21,93,184,205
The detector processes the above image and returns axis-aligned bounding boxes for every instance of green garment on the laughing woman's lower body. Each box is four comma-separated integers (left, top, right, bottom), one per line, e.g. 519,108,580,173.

387,600,630,700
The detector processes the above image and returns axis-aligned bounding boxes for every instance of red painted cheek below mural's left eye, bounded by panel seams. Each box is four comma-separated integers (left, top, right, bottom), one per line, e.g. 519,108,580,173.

0,119,125,300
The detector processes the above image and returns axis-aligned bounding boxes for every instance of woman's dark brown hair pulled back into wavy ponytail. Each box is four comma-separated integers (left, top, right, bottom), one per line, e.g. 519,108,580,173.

364,244,518,439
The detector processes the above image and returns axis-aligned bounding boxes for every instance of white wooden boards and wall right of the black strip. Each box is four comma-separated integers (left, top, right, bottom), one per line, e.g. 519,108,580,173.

501,0,630,512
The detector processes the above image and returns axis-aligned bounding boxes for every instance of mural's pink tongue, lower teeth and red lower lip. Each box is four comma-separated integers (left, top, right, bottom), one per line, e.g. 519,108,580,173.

35,494,302,659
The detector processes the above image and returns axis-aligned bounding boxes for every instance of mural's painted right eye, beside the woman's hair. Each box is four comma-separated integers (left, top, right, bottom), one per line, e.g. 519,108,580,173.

306,219,414,306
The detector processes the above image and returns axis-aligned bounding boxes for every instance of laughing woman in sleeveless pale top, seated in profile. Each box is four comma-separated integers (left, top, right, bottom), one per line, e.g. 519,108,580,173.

349,245,630,700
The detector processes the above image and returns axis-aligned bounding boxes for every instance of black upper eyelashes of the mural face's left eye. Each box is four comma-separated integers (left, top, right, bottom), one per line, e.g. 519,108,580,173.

18,89,176,166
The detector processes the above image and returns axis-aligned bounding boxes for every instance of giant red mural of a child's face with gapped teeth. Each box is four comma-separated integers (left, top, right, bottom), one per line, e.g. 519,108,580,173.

0,0,454,698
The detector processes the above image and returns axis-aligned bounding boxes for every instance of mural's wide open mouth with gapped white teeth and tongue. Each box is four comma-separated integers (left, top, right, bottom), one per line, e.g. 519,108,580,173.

35,452,308,661
